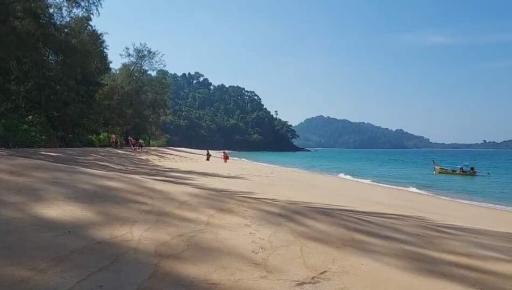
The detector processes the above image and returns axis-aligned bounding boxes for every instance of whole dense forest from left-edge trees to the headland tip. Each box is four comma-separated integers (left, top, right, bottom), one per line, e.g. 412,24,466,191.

0,0,299,150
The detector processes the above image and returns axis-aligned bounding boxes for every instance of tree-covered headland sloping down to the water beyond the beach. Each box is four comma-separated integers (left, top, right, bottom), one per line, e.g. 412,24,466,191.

164,73,298,150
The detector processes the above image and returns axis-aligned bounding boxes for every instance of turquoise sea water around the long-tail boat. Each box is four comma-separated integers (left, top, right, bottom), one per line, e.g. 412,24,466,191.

233,149,512,210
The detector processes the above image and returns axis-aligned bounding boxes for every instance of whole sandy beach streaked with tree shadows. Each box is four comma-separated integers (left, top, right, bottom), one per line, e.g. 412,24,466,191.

0,148,512,290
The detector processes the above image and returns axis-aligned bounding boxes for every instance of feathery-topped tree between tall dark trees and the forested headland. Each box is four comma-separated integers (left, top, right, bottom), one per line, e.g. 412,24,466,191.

99,43,170,142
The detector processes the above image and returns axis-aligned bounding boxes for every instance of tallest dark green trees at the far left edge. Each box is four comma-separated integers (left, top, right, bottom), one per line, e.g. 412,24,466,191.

0,0,109,147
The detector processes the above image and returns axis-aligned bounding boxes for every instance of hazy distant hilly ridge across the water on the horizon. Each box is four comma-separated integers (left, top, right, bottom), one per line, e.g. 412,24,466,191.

294,116,512,149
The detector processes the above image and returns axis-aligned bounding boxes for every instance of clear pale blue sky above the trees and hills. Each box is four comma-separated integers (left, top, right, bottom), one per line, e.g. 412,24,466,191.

94,0,512,142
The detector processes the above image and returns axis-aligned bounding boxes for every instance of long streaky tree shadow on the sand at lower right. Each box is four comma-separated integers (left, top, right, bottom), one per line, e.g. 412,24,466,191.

235,196,512,290
